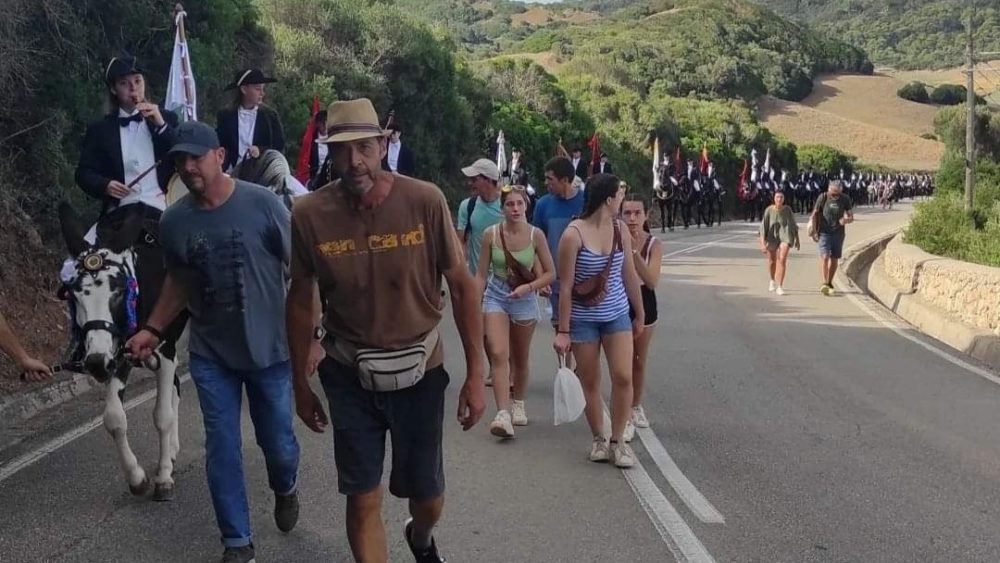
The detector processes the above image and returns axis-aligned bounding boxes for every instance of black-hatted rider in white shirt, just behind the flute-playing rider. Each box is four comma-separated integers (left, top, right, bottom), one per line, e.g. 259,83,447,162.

215,68,285,170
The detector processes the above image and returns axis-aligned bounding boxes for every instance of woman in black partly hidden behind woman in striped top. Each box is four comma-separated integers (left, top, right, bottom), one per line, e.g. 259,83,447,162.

622,194,663,428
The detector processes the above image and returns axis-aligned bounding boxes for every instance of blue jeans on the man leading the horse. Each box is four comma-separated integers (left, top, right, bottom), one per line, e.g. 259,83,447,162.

191,354,299,547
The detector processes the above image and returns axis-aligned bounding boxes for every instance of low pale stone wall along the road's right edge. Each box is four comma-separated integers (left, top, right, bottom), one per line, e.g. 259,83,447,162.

883,235,1000,336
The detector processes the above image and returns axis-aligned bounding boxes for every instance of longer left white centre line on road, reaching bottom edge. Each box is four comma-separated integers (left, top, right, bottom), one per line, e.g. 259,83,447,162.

604,405,715,563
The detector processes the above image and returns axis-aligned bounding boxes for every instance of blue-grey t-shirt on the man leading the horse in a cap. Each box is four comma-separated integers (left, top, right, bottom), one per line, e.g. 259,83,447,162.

160,180,291,370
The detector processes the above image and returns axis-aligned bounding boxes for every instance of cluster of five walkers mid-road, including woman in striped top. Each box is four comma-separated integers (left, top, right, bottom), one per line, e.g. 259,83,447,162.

457,157,662,468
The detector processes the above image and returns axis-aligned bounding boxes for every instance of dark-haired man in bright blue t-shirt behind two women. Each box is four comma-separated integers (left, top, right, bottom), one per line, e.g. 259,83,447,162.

531,156,584,367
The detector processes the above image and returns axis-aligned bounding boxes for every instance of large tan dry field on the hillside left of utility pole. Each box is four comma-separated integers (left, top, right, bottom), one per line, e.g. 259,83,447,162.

759,75,944,170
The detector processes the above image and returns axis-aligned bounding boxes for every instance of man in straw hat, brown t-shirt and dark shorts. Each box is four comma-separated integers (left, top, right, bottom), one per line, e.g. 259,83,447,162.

287,99,486,562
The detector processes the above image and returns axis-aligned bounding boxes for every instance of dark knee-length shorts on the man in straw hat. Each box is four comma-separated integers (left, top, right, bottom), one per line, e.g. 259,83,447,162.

319,358,449,501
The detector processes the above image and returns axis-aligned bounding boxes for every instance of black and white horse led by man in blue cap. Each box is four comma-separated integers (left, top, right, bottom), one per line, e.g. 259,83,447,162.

59,203,187,501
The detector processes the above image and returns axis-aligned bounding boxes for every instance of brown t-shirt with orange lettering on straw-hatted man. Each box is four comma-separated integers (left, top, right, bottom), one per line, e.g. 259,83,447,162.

291,176,458,369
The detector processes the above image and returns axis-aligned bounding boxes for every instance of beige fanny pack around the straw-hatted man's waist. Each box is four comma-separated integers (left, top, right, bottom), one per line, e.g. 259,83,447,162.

323,328,440,393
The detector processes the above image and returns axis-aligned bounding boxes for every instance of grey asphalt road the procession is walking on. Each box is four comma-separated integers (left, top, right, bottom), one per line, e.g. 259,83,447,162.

0,200,1000,563
